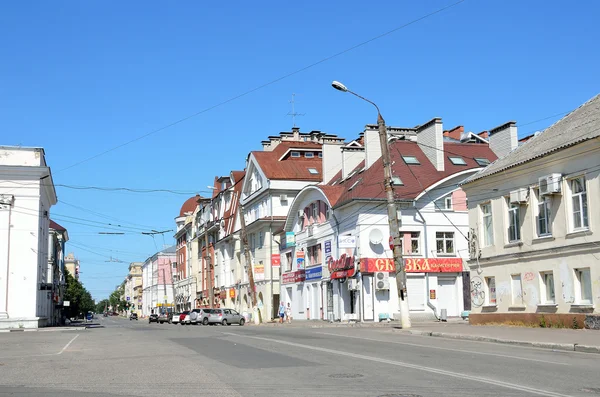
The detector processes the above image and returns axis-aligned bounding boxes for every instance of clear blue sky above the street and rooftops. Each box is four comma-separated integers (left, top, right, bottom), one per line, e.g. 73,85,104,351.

0,0,600,299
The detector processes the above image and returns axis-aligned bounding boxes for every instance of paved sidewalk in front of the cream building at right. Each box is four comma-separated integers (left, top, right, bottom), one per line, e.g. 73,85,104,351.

394,320,600,354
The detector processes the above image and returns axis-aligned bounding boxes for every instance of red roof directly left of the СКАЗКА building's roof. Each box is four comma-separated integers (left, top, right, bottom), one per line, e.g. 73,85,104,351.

252,142,323,182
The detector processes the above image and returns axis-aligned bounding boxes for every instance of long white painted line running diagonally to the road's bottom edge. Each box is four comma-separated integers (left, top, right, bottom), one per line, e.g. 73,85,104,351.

223,332,572,397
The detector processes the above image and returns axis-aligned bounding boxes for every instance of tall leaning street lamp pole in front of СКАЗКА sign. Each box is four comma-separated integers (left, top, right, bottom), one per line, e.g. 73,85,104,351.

331,81,410,329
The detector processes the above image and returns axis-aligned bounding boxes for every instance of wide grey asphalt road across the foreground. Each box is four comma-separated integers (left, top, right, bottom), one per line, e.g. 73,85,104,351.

0,317,600,397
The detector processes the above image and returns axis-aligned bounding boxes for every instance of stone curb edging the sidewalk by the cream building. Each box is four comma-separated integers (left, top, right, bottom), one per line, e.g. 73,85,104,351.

394,330,600,354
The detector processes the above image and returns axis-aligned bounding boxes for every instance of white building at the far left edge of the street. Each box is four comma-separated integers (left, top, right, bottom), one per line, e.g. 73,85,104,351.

0,146,56,328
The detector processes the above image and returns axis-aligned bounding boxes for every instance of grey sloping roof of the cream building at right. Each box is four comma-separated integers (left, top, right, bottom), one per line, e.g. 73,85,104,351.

465,94,600,183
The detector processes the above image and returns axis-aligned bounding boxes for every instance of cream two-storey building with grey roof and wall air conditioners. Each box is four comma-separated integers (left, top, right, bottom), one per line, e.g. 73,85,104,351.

463,96,600,327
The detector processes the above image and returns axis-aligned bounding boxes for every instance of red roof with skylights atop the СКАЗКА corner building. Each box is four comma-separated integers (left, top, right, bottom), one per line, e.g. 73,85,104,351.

332,141,497,206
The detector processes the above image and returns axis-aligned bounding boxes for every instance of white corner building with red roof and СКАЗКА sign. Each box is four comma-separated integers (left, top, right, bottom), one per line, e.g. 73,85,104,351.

281,118,496,321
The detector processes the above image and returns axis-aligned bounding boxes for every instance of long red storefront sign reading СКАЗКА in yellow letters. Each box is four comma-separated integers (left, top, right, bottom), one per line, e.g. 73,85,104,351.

360,258,463,273
